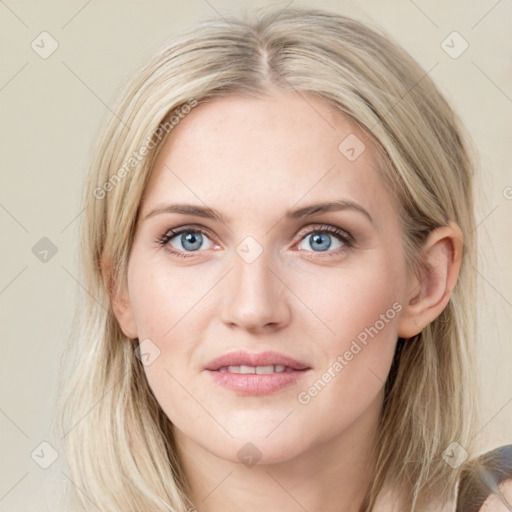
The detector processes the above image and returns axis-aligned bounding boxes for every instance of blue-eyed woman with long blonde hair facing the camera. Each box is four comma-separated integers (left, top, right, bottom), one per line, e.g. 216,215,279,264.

54,9,510,512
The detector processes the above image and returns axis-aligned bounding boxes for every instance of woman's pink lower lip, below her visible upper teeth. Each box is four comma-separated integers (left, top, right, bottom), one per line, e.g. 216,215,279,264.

206,370,309,396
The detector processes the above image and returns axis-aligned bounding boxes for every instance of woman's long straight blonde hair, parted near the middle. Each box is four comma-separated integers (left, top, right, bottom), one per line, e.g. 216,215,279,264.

55,8,477,512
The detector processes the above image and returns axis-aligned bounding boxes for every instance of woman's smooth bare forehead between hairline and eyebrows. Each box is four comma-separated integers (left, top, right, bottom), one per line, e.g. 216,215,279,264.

143,92,396,222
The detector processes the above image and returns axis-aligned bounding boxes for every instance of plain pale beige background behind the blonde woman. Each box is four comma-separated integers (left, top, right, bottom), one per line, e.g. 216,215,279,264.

0,0,512,512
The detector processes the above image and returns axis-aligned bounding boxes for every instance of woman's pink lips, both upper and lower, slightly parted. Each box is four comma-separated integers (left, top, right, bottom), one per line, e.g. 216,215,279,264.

204,350,310,396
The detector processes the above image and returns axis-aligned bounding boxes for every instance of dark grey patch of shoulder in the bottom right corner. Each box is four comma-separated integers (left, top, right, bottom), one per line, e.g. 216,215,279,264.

456,445,512,512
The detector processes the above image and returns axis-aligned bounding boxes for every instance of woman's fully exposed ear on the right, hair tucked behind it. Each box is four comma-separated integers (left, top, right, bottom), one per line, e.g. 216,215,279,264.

398,222,464,339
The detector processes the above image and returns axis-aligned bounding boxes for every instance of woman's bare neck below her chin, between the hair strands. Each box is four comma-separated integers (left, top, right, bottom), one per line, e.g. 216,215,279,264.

173,397,382,512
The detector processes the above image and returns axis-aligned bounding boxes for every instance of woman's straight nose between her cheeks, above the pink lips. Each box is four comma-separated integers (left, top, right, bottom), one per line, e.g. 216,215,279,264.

220,251,291,334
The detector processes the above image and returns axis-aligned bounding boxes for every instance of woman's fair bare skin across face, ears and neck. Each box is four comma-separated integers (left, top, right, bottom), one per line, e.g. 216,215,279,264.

113,91,462,512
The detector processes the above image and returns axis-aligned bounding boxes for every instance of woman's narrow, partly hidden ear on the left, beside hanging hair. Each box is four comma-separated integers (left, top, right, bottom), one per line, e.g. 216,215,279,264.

101,253,138,339
